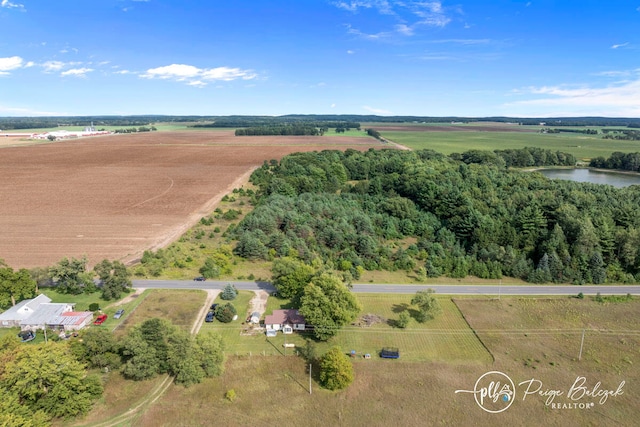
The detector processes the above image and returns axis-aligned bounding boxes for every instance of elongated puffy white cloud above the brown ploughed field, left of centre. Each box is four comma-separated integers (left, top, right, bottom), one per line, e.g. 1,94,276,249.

141,64,257,87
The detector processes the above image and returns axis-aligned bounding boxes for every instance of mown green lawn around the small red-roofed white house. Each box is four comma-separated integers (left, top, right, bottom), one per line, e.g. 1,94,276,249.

201,291,491,363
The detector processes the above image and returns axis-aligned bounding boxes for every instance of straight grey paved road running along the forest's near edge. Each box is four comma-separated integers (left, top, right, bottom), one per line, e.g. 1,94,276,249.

133,280,640,296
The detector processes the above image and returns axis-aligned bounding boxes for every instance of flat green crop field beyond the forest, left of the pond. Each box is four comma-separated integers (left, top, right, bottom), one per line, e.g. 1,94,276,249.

363,123,640,161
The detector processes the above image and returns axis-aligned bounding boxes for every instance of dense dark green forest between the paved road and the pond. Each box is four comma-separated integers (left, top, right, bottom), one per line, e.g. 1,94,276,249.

233,149,640,284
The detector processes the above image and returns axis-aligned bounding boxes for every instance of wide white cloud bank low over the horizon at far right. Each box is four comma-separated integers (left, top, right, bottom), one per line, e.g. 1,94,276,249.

507,75,640,117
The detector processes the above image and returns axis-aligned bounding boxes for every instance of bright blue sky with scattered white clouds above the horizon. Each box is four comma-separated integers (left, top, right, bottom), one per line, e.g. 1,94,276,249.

0,0,640,117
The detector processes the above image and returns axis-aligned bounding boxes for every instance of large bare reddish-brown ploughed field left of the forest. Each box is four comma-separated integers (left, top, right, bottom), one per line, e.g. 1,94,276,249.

0,131,380,268
